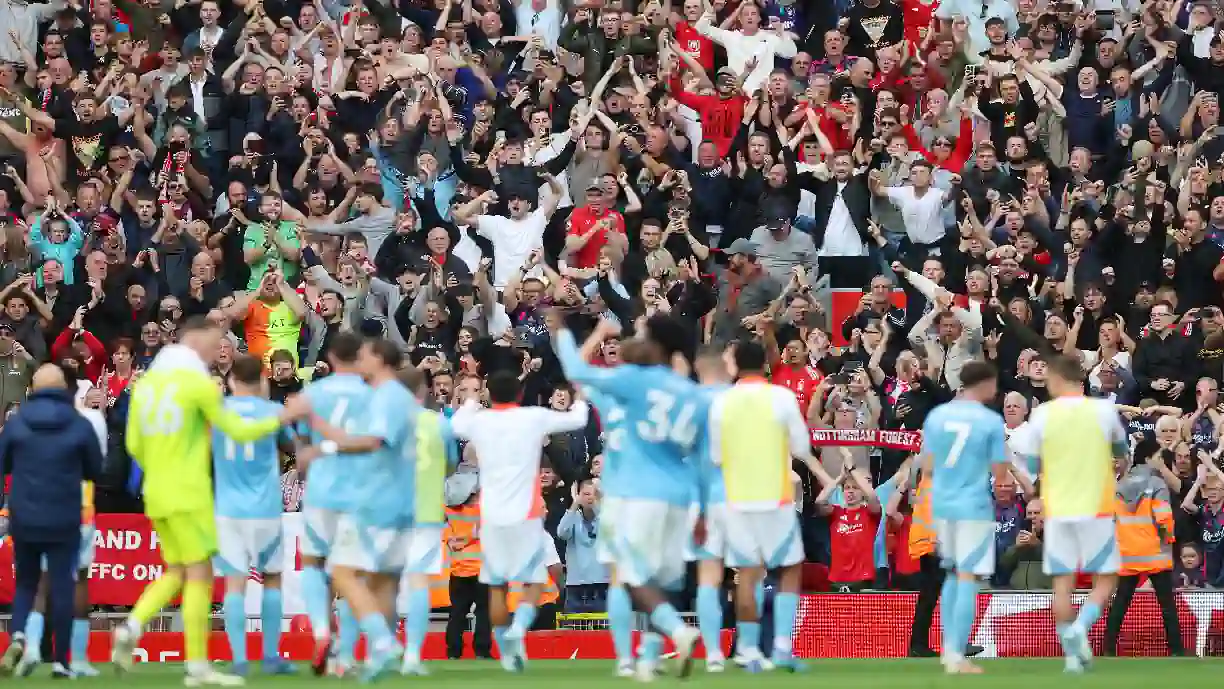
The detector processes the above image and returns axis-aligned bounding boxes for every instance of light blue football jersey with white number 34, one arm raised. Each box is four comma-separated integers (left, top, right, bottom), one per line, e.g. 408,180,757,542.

557,332,709,507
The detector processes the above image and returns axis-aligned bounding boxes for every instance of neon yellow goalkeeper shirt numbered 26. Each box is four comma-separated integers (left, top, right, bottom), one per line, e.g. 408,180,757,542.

126,345,280,519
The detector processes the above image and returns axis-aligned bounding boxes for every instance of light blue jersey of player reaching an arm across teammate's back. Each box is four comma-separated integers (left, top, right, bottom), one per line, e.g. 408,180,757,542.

351,379,422,529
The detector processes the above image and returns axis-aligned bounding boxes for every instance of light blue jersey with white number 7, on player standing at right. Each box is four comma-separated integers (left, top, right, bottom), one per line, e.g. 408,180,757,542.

922,400,1007,521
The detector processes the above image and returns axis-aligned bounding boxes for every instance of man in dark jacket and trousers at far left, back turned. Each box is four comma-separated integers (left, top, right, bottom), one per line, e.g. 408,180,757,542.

0,363,102,677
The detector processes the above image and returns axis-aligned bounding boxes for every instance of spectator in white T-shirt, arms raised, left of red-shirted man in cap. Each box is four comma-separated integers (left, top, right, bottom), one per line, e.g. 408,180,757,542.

454,173,562,289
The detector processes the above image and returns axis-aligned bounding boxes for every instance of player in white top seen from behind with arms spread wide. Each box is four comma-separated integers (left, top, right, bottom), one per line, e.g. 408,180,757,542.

450,371,589,672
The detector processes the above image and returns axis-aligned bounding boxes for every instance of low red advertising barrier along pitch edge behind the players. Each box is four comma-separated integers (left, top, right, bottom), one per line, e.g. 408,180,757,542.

0,590,1224,662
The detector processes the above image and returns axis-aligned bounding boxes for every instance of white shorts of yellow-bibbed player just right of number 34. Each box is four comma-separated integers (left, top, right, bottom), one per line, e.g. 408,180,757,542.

723,504,803,569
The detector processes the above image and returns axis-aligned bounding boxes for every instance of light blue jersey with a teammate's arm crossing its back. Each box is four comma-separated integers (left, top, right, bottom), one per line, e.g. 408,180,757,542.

302,373,372,513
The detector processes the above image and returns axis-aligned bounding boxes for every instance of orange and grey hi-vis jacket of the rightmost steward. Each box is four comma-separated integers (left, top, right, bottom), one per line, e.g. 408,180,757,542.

1115,464,1173,576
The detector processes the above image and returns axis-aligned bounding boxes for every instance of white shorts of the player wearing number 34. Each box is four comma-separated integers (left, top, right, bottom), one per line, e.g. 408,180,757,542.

596,498,693,589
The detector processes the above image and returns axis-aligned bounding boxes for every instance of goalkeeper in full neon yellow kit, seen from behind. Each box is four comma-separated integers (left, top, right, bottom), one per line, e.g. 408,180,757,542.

111,318,307,687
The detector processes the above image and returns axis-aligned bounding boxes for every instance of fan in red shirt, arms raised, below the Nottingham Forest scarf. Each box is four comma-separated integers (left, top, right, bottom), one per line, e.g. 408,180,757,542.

816,448,880,592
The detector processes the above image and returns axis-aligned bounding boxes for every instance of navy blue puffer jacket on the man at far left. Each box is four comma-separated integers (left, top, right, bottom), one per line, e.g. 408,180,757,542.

0,389,102,542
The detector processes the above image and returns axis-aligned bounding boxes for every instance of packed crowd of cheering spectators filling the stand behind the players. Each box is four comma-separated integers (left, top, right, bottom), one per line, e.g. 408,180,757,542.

0,0,1224,619
